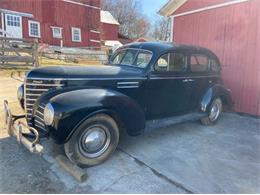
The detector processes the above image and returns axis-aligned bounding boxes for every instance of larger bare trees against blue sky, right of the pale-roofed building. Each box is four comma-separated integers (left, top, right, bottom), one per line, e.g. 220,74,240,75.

101,0,150,39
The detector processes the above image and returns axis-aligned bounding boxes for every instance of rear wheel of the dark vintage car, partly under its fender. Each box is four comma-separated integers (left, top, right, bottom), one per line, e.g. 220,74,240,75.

201,98,222,125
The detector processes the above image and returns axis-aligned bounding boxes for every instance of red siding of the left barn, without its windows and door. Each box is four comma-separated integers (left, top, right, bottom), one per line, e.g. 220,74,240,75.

0,0,100,47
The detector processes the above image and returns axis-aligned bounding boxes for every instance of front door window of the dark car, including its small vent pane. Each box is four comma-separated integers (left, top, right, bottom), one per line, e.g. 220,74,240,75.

155,53,187,72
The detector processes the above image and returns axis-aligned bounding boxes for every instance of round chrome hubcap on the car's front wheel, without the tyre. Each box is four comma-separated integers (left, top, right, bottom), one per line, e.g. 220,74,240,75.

79,125,111,158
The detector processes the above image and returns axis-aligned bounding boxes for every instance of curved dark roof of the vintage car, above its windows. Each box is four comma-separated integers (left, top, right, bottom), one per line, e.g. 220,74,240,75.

122,42,217,57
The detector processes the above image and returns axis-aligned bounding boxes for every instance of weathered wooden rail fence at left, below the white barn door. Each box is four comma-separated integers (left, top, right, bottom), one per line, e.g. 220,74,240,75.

0,37,39,68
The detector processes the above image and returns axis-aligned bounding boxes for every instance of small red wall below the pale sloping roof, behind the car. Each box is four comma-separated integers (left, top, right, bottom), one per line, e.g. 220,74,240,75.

101,23,119,40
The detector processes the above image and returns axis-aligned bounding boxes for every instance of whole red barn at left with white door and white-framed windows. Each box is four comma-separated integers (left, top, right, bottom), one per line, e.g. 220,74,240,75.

0,0,100,47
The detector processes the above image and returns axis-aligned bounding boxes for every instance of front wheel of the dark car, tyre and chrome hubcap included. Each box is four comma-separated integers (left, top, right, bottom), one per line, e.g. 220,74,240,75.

64,114,119,166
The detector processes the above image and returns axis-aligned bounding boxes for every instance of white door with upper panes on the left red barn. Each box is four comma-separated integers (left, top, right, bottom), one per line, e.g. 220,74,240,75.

5,14,23,38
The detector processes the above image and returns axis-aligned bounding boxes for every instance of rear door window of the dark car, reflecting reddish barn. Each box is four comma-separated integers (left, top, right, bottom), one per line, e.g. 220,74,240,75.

190,54,209,72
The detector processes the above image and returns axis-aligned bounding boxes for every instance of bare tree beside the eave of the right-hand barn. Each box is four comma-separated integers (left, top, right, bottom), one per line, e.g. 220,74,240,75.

150,17,171,41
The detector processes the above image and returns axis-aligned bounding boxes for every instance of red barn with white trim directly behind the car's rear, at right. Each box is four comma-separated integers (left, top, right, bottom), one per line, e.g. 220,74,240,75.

159,0,260,116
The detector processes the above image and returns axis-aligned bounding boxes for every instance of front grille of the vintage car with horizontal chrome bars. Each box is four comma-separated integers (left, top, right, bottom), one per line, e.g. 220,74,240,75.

25,78,64,130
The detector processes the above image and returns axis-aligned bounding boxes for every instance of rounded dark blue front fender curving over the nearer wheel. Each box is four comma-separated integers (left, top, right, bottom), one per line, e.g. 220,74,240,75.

45,89,145,143
